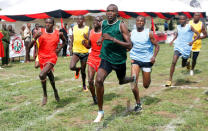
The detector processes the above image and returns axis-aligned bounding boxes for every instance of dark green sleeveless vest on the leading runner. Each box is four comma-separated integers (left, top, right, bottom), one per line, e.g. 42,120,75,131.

100,20,127,64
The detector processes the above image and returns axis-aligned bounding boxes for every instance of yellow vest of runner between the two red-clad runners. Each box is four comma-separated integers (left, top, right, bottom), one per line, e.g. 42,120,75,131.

73,25,89,53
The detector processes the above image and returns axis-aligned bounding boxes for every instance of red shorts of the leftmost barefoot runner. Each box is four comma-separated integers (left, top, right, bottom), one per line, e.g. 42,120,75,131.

38,56,57,70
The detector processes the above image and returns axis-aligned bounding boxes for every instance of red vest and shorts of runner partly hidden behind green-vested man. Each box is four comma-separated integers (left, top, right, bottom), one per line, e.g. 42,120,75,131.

87,29,102,71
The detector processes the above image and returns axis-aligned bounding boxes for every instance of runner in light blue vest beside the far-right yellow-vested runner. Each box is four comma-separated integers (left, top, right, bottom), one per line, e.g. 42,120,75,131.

166,15,199,87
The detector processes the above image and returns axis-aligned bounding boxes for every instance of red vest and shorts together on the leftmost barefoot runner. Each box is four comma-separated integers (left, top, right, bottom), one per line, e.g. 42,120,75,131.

38,28,59,70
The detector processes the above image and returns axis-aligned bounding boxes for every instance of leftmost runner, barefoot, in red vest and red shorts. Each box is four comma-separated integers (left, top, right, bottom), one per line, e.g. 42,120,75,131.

30,18,66,106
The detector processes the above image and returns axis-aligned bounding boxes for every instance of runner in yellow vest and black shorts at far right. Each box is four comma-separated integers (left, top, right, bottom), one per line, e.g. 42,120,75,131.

189,13,207,76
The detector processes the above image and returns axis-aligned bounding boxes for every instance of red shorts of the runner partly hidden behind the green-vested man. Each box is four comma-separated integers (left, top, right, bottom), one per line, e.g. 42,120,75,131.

87,54,101,72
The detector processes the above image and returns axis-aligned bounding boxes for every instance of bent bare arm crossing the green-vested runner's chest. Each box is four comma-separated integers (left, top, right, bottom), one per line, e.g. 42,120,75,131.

100,22,132,50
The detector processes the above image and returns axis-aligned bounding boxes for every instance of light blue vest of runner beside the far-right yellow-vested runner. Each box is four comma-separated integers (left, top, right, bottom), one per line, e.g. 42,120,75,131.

174,24,194,58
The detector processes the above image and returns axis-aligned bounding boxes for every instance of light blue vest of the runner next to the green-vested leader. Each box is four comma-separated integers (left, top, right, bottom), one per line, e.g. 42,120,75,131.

130,29,153,62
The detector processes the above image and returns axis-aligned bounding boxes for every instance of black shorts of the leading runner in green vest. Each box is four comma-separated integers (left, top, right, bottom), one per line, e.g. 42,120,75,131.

99,59,126,80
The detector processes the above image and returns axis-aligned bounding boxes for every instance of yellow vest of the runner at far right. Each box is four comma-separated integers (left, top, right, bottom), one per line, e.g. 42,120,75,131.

189,20,202,51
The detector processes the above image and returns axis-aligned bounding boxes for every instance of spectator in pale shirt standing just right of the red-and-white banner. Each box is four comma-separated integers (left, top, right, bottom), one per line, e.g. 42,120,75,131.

24,23,32,63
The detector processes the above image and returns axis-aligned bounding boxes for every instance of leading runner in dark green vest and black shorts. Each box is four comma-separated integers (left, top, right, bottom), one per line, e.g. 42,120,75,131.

94,4,135,122
